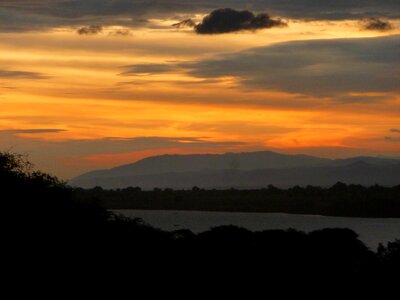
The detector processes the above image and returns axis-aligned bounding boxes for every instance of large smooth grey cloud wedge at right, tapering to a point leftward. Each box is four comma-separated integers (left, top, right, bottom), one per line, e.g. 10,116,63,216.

181,36,400,96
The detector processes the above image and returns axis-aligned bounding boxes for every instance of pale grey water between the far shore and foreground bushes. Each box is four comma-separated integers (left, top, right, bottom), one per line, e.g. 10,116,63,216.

115,210,400,250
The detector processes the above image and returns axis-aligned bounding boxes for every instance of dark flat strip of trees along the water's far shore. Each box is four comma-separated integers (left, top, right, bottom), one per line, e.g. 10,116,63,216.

74,183,400,217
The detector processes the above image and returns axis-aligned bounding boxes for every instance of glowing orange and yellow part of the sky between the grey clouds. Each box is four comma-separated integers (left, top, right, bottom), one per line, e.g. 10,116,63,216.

0,16,400,178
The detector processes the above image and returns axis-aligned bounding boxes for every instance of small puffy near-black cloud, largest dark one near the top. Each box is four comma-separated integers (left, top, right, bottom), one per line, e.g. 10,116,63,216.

195,8,286,34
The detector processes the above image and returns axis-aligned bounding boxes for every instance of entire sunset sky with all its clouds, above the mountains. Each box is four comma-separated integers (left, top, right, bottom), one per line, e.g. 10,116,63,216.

0,0,400,179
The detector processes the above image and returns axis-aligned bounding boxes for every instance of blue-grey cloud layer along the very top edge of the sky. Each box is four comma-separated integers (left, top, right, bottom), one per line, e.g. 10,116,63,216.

0,0,400,31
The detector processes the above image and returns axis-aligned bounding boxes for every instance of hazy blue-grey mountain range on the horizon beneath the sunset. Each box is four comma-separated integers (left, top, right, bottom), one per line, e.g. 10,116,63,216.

71,151,400,189
